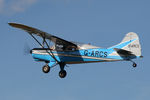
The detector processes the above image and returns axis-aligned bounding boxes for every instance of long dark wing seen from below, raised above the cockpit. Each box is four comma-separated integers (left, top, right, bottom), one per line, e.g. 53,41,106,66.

8,23,77,48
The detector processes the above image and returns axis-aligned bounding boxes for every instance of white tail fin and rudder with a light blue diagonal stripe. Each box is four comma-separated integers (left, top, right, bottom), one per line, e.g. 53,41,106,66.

111,32,141,57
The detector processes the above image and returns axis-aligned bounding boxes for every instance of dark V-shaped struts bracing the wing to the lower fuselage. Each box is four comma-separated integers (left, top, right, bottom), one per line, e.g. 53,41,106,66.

29,33,59,63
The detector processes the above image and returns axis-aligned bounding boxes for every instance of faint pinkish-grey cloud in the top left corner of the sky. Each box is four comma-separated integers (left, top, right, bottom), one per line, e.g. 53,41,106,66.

0,0,37,14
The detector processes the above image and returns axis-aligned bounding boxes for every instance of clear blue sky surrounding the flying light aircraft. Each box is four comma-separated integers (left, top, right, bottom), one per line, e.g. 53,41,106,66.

0,0,150,100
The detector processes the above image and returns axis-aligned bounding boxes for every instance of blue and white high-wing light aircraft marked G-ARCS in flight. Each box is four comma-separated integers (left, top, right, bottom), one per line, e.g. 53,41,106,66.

8,23,142,78
